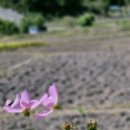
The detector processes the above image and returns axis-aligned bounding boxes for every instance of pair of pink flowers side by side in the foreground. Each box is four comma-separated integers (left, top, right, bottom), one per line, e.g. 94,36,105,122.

3,84,58,119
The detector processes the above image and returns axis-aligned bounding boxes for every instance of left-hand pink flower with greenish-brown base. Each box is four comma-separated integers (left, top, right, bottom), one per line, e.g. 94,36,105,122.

3,90,40,116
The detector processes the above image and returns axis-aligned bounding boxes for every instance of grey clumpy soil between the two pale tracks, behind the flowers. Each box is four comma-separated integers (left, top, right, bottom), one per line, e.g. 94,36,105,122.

1,50,130,107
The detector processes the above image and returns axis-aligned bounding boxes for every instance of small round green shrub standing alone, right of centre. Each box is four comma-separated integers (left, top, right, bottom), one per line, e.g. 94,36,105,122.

78,13,95,27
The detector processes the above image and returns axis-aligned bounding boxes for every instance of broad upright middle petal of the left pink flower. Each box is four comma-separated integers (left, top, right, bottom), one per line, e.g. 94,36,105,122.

21,90,30,104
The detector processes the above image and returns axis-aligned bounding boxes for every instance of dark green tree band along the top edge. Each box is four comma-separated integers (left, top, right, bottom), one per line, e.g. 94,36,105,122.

0,0,130,17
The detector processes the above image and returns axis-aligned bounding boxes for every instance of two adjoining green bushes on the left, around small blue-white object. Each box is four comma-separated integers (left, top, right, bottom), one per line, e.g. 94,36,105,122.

0,13,46,35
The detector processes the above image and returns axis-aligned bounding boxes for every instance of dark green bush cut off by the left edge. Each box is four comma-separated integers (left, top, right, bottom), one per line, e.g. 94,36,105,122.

0,19,19,35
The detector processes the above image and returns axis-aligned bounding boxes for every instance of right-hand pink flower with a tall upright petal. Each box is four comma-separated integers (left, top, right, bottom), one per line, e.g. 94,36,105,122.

36,83,58,119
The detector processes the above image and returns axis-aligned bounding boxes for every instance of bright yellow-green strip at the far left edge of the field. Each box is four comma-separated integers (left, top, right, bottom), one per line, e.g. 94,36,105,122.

0,42,45,51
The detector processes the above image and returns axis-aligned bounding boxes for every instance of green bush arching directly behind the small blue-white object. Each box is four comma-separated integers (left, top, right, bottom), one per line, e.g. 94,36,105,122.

19,13,46,33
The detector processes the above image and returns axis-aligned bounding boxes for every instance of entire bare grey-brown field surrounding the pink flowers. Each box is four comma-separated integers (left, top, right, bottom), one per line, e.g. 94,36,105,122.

0,29,130,130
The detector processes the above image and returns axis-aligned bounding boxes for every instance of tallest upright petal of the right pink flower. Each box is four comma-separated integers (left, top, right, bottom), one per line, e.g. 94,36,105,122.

49,83,58,105
